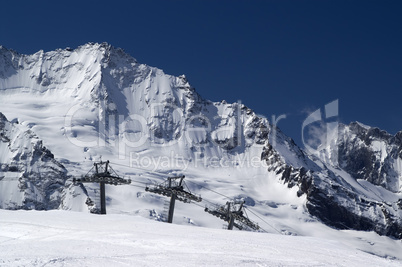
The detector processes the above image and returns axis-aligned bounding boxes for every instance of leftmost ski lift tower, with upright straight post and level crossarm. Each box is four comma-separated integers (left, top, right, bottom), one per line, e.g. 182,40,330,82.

73,161,131,214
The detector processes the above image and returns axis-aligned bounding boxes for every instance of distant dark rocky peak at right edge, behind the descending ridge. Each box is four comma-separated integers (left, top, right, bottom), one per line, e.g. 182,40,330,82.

338,123,402,193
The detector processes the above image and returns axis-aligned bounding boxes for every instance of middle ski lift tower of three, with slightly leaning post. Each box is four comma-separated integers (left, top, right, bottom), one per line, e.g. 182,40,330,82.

145,175,202,223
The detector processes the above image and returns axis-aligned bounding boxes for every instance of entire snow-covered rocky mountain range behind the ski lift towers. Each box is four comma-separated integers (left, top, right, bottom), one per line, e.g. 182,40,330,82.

0,43,402,256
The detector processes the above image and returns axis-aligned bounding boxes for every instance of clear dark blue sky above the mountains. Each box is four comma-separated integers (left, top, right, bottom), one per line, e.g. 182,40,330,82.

0,0,402,147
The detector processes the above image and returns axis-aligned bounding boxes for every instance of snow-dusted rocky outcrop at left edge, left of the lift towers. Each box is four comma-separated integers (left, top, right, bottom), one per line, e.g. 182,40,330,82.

0,113,67,210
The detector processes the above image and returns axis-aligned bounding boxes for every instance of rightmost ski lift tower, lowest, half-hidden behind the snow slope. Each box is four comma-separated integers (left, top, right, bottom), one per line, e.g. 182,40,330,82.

205,200,260,231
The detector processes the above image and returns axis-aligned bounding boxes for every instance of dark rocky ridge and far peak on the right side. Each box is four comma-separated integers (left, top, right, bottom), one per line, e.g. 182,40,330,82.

262,123,402,239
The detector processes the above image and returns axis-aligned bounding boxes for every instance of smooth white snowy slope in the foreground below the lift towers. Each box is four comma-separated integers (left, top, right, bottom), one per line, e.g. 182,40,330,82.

0,210,401,266
